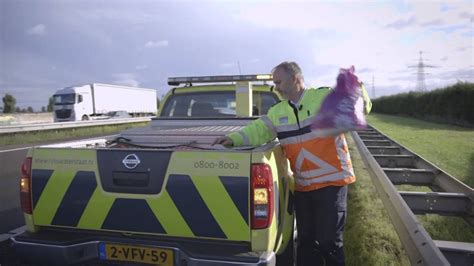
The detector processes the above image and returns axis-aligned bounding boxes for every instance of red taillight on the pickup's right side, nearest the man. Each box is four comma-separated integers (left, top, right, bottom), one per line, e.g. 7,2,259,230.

251,163,274,229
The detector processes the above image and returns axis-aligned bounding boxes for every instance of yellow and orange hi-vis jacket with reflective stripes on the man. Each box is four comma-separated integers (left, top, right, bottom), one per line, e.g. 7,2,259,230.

228,84,372,191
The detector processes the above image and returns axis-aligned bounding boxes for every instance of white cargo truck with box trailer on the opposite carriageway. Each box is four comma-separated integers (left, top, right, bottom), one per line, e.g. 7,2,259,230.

53,83,157,122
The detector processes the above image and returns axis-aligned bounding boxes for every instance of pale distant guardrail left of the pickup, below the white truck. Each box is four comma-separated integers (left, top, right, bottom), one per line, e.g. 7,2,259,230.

0,117,151,135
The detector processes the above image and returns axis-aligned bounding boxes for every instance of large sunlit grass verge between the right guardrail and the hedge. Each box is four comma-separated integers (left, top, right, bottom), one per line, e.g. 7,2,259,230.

368,114,474,187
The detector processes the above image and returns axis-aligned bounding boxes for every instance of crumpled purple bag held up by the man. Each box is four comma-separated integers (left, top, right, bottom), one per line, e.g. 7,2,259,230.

311,66,367,136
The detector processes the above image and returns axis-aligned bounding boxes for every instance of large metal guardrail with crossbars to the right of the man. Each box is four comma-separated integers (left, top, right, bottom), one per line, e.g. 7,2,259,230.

352,125,474,265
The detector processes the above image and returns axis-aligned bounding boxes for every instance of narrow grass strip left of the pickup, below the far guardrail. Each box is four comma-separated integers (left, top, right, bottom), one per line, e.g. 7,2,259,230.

0,122,148,147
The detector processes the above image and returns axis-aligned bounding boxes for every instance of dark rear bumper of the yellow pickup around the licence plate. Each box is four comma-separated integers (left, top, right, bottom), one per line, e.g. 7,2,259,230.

11,232,276,266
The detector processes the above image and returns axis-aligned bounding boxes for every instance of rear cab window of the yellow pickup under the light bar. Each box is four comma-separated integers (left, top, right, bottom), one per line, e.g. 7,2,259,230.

160,91,278,117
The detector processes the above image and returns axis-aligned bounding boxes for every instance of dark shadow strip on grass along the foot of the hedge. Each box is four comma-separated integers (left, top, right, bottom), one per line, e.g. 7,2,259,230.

369,113,473,132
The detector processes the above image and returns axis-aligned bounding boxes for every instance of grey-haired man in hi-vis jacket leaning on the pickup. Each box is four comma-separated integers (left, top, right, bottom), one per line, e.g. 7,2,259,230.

214,62,371,265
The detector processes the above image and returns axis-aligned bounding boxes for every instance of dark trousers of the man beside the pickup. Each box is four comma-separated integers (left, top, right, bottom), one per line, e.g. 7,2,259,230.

295,186,347,266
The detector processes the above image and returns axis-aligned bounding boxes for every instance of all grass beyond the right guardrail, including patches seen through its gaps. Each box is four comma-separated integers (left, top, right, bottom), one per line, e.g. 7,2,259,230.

369,114,474,243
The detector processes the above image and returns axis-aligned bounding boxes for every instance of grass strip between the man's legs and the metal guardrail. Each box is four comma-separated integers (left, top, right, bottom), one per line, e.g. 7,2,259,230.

344,134,410,265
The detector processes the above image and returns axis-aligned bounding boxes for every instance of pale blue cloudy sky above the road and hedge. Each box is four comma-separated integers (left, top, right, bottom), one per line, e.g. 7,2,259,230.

0,0,474,110
